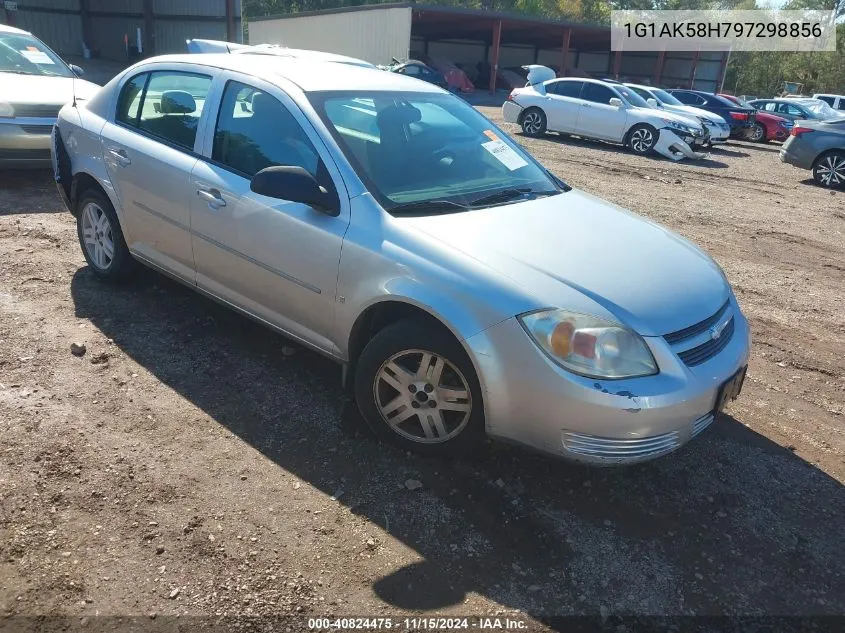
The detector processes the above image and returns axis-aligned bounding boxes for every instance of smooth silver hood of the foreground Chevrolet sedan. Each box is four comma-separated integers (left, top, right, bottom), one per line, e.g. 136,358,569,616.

402,190,730,336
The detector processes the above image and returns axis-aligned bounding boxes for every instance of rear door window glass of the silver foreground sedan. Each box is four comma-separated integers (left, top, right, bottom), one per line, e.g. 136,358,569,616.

133,71,211,150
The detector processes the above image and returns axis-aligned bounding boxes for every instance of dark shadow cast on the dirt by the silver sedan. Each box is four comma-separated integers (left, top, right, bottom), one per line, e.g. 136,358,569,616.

71,268,845,630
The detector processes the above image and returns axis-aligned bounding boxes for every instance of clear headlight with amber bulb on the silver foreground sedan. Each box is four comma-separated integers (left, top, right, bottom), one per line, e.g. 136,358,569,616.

519,309,657,378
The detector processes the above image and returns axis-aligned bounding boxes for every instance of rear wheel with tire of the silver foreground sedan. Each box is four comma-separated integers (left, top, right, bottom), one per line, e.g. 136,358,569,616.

76,189,135,281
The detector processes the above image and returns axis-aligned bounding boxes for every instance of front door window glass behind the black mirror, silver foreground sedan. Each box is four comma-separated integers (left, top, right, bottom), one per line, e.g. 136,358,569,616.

211,81,320,178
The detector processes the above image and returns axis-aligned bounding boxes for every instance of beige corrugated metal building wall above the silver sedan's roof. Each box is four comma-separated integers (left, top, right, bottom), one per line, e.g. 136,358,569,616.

249,7,411,64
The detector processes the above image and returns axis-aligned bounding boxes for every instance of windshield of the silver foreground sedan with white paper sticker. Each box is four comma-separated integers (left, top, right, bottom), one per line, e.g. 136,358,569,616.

309,91,565,214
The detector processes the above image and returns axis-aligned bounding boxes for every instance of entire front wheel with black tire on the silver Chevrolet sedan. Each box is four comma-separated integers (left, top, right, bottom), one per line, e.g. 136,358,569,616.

355,319,484,456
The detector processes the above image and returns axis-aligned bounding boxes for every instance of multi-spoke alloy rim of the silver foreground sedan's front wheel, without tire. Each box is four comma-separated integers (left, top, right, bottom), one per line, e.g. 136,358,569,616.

373,349,472,444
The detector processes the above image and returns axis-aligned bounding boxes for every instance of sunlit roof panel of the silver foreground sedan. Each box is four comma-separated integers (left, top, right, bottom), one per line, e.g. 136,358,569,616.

133,53,443,92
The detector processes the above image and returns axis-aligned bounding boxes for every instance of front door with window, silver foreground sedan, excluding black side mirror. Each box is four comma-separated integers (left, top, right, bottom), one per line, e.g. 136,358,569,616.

191,73,349,353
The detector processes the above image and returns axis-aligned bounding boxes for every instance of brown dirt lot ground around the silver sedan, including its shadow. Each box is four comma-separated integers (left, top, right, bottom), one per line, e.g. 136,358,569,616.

0,109,845,630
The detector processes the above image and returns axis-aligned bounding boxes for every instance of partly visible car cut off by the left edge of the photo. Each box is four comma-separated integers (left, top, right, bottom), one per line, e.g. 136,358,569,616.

0,24,100,171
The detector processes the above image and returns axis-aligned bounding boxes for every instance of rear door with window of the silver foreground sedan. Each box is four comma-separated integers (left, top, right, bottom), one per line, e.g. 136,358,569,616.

101,64,214,282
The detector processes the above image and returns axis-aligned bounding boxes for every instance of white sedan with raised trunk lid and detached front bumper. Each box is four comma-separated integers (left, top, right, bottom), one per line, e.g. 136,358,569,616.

502,73,708,160
